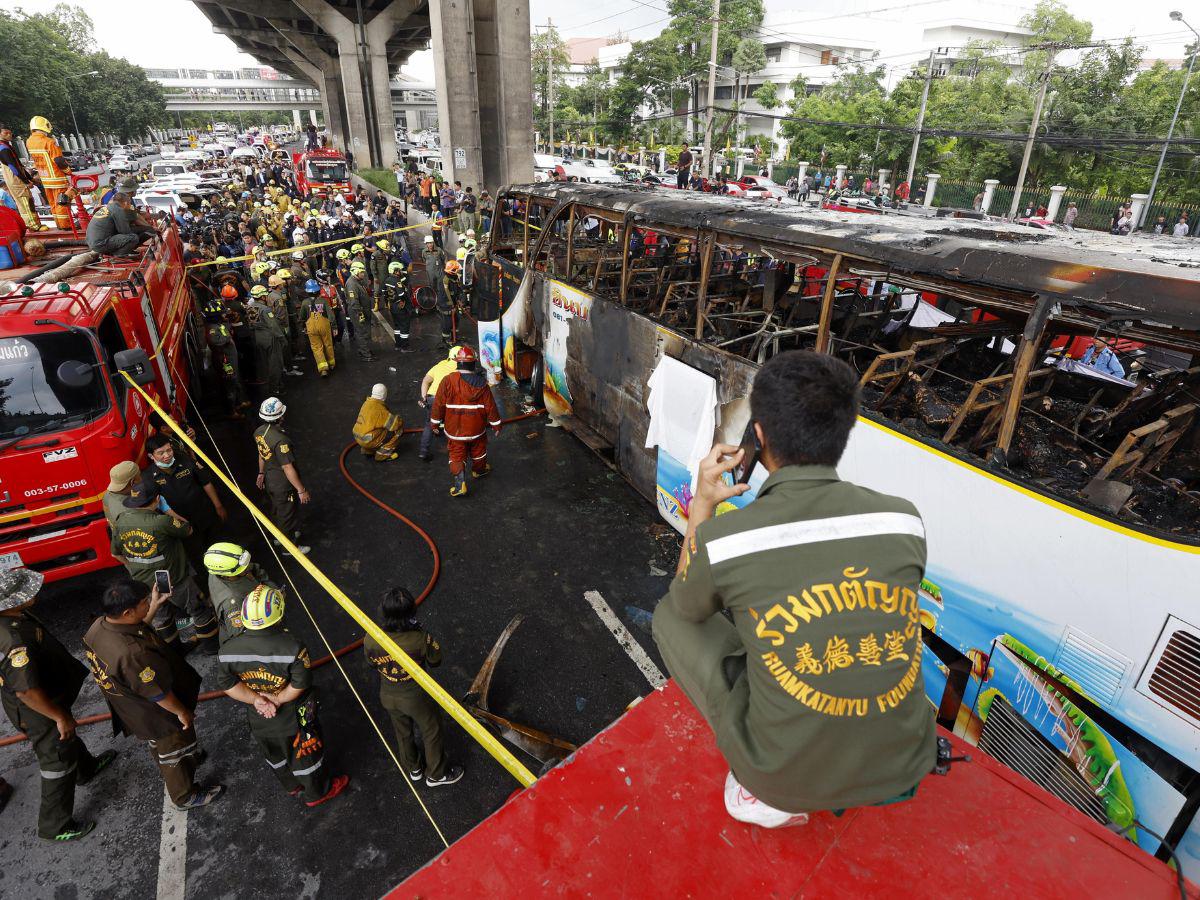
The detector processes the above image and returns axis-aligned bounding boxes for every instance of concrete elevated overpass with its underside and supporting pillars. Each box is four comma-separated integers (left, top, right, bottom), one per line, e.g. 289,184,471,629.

192,0,533,188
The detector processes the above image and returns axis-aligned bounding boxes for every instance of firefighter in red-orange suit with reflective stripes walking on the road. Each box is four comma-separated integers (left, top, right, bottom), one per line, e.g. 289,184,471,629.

430,347,500,497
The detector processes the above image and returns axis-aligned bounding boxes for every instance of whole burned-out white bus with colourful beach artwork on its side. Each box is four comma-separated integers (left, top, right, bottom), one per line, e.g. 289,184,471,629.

479,184,1200,866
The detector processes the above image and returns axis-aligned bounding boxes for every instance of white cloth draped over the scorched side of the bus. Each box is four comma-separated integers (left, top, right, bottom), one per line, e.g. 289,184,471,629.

646,356,718,482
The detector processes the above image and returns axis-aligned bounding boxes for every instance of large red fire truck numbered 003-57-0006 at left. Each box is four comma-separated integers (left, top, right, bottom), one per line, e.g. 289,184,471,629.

0,224,203,581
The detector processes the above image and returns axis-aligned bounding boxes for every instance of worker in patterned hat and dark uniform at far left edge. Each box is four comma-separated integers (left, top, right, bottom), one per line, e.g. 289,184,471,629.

0,569,116,841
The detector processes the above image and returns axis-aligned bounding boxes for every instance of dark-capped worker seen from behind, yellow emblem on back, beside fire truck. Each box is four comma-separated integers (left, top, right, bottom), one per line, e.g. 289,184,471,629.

110,481,217,652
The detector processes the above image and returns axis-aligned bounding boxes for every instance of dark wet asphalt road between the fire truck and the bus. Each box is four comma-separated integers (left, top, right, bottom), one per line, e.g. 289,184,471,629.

0,301,678,900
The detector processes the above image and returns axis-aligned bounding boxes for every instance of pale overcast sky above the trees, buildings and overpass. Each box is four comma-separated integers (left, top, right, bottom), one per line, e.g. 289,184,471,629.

5,0,1200,82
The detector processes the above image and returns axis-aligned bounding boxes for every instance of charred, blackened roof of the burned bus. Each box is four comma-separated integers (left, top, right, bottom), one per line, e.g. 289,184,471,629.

506,182,1200,350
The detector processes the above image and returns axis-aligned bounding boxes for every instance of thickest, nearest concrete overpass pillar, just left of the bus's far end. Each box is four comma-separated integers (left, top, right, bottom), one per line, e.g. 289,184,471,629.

430,0,533,191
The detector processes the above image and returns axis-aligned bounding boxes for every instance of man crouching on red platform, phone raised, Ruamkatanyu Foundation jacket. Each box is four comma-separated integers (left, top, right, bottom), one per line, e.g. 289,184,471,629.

654,350,937,828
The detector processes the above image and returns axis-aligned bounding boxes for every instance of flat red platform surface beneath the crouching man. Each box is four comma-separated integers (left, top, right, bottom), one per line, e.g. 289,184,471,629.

388,682,1200,900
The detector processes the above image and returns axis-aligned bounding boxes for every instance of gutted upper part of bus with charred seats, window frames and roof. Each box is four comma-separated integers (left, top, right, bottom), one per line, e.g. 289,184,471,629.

490,185,1200,542
